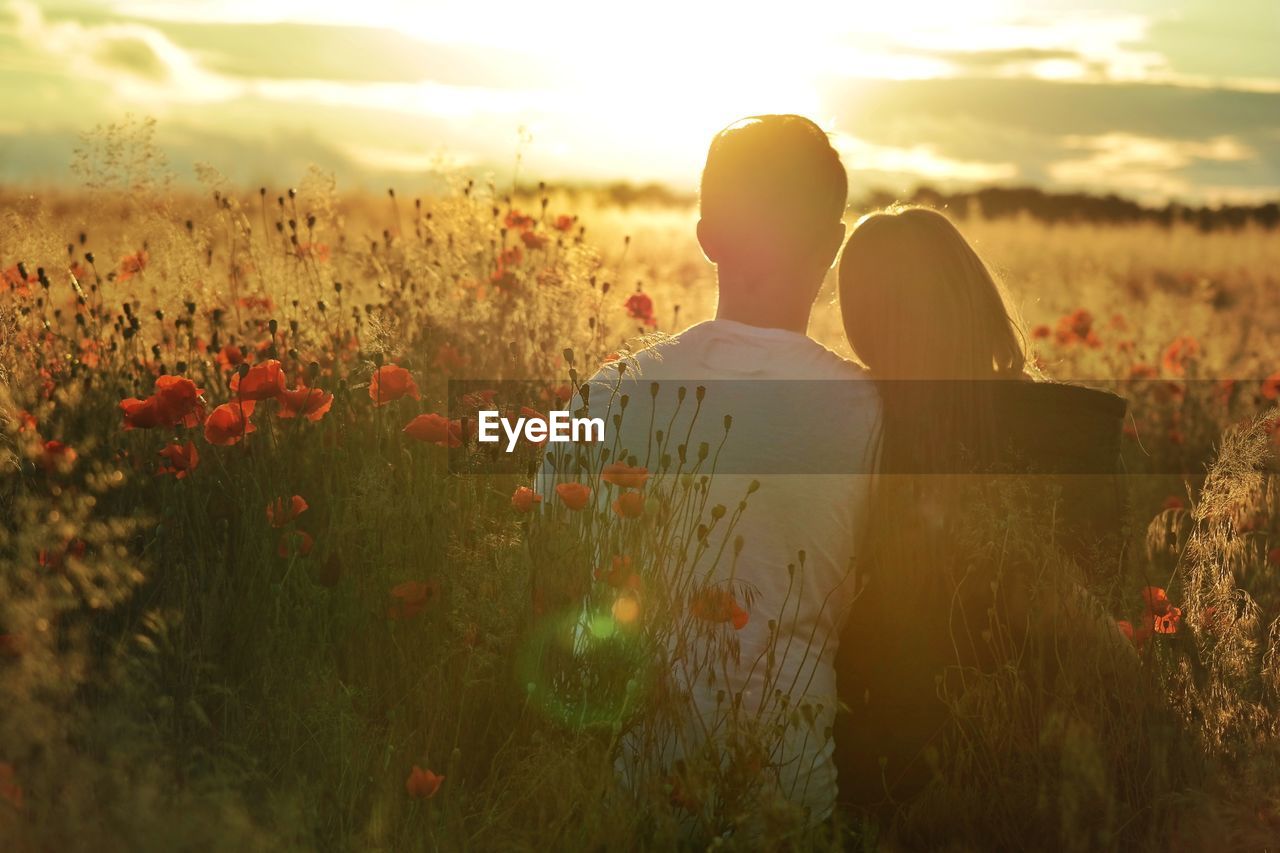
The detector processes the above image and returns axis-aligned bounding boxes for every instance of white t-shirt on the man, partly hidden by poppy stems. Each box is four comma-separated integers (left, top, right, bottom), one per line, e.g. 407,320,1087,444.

540,320,879,821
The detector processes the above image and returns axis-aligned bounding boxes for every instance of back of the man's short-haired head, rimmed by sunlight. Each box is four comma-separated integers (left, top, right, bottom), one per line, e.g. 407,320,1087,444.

698,115,849,295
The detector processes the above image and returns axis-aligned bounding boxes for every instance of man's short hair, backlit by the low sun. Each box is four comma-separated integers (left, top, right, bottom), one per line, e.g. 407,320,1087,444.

700,115,849,247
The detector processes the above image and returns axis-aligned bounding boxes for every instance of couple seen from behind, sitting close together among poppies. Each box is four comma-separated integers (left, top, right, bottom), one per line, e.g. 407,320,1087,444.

540,115,1124,822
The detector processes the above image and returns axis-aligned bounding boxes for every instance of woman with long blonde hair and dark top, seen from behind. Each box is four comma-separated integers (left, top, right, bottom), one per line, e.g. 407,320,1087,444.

835,207,1125,816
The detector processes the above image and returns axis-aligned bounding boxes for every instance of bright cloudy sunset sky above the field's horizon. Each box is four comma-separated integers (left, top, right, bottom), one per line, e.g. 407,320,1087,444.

0,0,1280,204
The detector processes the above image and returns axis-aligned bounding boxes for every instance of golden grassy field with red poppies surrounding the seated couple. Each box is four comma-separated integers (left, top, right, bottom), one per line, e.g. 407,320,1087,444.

0,140,1280,850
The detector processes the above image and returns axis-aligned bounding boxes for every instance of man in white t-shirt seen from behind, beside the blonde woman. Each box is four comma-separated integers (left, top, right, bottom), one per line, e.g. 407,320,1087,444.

544,115,878,821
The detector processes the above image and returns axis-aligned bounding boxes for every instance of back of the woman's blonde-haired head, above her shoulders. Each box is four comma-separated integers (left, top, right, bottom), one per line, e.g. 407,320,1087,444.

840,207,1027,379
